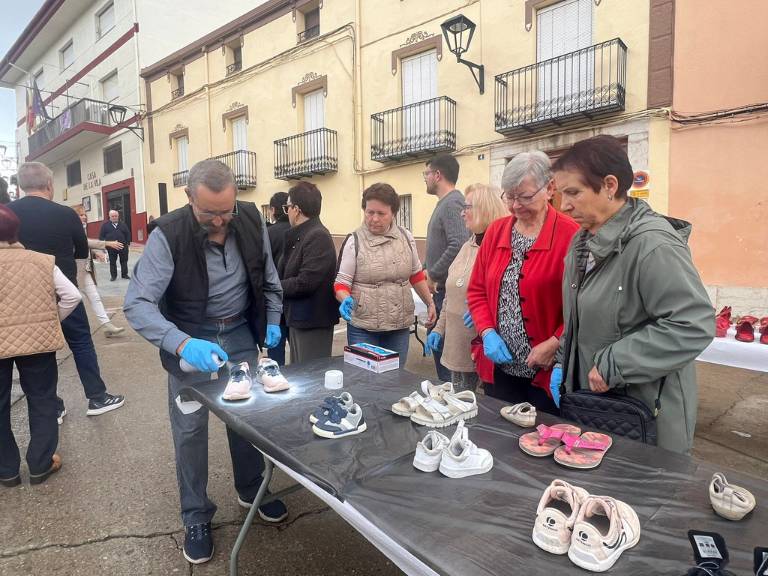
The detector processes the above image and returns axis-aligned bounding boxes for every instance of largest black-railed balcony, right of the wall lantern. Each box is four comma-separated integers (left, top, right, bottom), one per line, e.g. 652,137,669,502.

494,38,627,136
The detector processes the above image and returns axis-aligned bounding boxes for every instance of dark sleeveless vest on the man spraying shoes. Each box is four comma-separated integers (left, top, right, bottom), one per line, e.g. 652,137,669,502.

155,202,266,375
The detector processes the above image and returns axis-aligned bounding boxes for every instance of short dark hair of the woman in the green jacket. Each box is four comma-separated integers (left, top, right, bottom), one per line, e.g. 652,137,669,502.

552,134,635,198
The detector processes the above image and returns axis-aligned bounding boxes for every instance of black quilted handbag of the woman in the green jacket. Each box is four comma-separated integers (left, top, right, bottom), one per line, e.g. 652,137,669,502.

560,380,664,446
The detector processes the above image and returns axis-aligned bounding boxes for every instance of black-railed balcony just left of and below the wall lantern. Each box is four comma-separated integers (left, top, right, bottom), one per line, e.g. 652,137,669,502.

371,96,456,162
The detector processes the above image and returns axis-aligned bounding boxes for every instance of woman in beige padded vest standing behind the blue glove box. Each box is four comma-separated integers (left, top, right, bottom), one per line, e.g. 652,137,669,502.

334,183,437,367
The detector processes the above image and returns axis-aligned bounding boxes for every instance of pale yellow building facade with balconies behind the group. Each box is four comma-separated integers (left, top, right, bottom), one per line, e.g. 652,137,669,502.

142,0,669,245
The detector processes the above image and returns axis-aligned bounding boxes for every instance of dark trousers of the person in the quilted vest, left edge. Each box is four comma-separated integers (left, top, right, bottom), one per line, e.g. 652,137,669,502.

0,352,59,479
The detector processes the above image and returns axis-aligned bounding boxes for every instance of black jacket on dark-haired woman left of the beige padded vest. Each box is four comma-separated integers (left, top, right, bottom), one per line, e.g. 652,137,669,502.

278,218,339,330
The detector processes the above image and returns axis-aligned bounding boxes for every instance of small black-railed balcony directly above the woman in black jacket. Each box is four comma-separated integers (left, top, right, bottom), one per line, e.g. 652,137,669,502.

275,128,339,180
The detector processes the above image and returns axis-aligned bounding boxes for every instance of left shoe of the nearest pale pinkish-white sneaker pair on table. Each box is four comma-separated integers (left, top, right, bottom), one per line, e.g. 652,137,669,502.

532,480,589,554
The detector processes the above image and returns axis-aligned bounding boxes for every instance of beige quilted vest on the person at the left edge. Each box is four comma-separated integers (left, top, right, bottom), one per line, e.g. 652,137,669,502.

0,242,80,358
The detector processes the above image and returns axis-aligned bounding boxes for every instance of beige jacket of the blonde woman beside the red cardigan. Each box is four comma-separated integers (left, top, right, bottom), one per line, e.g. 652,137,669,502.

434,236,479,372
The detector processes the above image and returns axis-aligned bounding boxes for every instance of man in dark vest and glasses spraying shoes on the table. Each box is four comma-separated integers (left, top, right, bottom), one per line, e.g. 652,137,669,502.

123,160,288,564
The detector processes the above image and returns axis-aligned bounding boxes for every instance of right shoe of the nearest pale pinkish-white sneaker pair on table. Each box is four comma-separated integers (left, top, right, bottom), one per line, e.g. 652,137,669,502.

568,496,640,572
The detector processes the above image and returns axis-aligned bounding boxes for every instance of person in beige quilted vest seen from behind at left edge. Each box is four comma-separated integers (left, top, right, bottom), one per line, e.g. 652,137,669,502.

0,205,80,488
